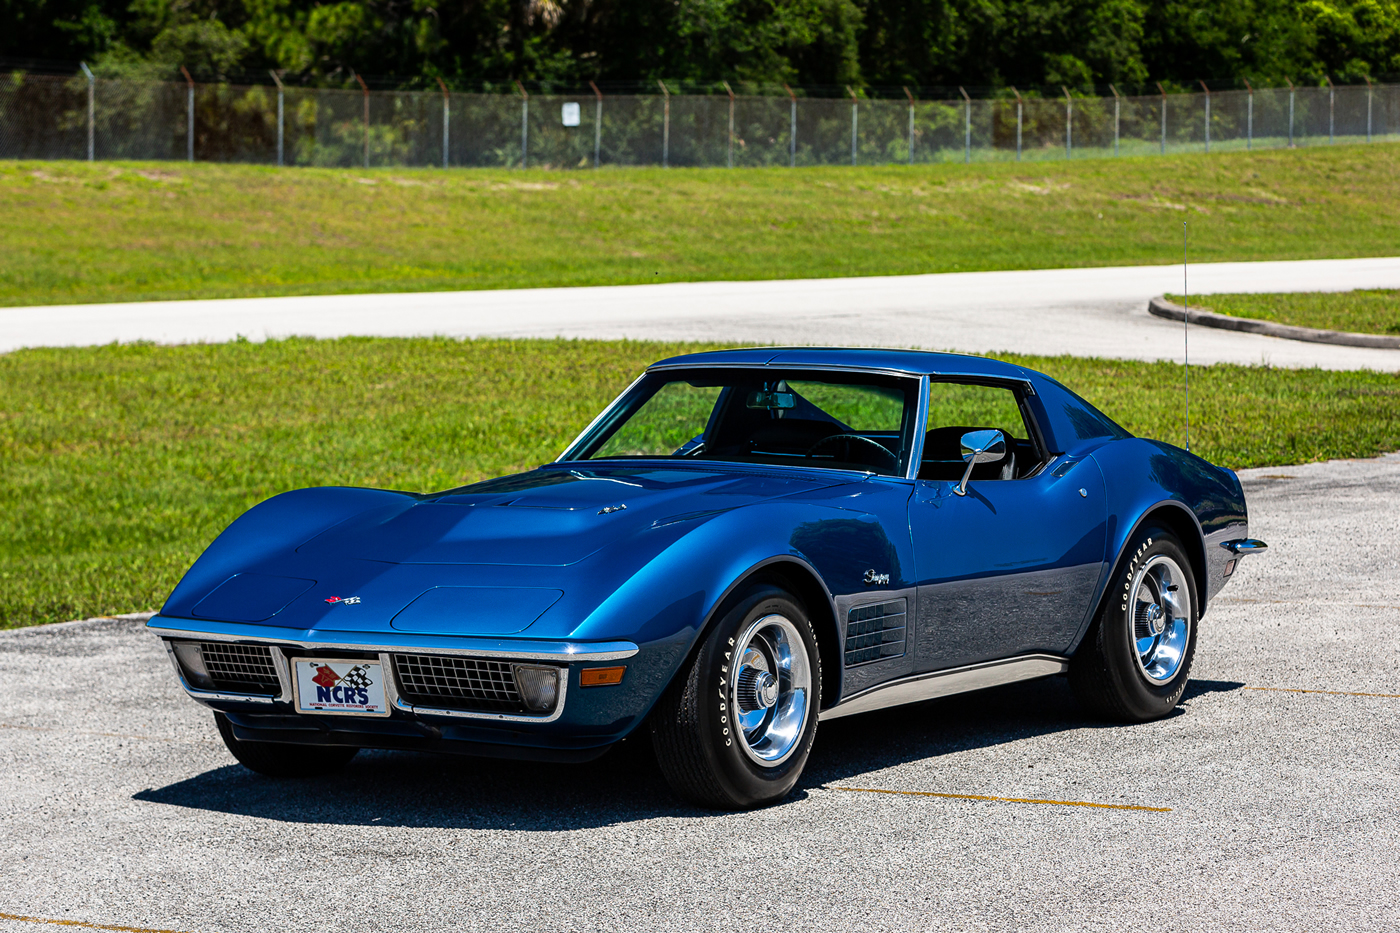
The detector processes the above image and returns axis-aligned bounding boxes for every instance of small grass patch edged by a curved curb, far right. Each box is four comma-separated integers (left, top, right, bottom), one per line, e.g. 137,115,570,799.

1168,289,1400,335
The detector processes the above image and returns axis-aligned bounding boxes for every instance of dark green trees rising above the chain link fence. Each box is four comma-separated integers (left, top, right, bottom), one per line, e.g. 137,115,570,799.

0,0,1400,90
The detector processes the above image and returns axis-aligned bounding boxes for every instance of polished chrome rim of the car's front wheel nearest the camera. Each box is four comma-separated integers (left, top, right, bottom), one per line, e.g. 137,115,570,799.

728,614,812,768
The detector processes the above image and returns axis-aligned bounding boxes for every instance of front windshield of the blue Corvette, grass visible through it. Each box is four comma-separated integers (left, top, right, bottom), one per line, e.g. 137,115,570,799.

561,367,918,476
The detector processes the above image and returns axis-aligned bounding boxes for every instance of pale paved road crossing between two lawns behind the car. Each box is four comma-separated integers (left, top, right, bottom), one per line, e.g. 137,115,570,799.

8,259,1400,371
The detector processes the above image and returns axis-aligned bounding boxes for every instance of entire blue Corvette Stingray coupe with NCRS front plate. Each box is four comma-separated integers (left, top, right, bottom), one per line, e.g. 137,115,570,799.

150,349,1264,808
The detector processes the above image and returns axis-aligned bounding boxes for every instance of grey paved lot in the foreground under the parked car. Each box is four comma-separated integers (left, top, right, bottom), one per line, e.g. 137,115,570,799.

0,455,1400,933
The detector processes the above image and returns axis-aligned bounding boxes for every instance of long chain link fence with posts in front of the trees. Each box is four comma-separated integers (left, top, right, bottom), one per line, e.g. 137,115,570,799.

0,73,1400,168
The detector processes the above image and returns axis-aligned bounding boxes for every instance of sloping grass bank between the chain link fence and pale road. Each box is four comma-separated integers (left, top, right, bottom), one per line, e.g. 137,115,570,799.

8,144,1400,305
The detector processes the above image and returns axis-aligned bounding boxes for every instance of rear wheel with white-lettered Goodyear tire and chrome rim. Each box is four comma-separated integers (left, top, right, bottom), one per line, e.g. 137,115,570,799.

1070,528,1200,723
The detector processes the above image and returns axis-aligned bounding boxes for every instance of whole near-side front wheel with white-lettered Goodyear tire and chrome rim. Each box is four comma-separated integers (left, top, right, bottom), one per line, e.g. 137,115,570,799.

651,586,822,810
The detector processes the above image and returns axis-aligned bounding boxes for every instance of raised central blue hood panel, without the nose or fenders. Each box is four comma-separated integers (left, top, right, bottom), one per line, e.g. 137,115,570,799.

297,468,850,566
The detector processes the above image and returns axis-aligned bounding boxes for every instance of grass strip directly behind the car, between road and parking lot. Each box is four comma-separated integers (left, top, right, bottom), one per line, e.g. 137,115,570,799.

0,338,1400,626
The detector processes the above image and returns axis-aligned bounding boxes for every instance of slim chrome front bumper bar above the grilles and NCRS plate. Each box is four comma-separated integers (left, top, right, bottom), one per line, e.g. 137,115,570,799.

146,615,640,664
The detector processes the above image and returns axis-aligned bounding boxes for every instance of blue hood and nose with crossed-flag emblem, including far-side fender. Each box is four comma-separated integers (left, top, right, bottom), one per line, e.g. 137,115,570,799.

162,465,864,635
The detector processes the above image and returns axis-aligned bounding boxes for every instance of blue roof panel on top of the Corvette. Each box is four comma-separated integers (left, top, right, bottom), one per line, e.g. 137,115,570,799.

650,346,1037,380
